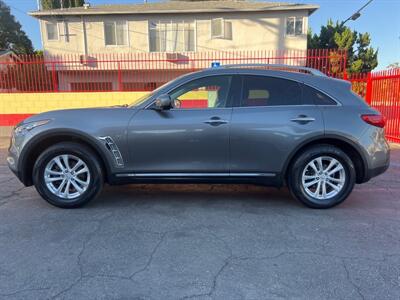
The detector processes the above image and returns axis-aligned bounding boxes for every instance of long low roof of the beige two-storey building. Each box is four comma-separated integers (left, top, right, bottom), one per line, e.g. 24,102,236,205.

29,0,319,18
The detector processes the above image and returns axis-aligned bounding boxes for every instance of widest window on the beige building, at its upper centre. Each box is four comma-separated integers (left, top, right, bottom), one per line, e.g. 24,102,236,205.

149,21,196,52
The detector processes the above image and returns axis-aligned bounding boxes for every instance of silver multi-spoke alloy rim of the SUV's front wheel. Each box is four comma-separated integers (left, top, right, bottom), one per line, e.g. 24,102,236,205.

44,154,90,199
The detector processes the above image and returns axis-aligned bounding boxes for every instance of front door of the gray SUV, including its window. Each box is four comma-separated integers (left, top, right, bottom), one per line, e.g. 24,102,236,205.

129,76,232,176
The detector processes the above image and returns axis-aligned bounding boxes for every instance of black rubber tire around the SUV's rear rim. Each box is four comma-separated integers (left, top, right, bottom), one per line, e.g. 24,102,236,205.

287,144,356,209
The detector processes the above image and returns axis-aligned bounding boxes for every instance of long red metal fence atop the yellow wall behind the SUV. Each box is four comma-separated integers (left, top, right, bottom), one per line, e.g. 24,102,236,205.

0,49,346,93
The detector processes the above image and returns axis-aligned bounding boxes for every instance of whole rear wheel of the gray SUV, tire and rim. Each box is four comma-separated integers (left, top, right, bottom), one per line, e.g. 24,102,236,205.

288,145,356,208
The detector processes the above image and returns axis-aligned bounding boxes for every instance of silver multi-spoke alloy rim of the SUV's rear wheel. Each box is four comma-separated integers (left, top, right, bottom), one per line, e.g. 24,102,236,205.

301,156,346,200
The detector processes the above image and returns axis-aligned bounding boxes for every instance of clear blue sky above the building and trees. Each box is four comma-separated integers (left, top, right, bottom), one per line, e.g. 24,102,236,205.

3,0,400,70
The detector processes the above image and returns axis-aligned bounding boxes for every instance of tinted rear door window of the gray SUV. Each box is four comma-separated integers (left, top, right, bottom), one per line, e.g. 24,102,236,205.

241,76,301,106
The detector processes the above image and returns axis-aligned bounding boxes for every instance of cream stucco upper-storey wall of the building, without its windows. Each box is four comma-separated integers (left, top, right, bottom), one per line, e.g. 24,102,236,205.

41,10,308,54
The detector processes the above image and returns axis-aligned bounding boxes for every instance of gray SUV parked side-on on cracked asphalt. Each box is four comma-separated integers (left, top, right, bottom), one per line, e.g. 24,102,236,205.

7,65,389,208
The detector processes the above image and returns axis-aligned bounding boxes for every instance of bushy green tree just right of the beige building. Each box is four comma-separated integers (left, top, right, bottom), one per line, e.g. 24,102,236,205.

307,20,378,73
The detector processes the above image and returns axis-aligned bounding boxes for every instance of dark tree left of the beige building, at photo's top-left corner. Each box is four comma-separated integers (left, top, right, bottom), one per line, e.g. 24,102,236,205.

0,0,33,54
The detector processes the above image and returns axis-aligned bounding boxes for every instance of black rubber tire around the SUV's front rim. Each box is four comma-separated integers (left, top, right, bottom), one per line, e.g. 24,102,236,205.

33,142,104,208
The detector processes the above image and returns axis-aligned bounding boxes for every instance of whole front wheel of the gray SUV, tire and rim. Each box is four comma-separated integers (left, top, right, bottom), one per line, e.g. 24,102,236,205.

33,142,103,208
